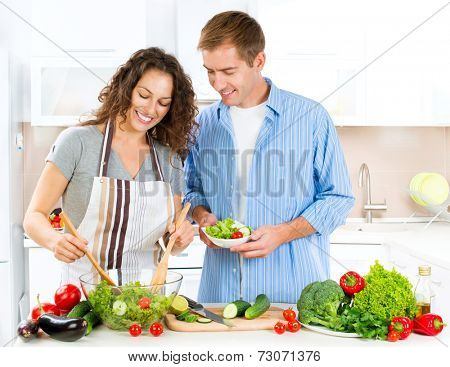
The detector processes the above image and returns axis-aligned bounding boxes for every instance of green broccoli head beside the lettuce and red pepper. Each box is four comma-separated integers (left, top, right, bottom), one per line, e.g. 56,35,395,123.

297,279,345,330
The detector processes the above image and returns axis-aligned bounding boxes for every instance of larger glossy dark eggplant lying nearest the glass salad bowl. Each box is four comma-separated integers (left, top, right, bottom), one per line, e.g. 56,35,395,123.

39,313,88,342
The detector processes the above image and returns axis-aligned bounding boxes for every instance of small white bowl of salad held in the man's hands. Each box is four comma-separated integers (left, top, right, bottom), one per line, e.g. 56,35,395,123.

201,218,253,248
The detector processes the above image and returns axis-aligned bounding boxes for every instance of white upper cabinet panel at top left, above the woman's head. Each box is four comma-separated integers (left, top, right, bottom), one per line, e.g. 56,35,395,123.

31,0,146,57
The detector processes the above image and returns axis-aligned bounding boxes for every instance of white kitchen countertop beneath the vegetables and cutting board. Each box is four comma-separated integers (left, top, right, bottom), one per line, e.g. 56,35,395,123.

14,304,450,350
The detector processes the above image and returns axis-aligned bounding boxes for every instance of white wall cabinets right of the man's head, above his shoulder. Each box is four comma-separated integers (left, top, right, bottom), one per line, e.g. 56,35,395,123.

252,0,450,126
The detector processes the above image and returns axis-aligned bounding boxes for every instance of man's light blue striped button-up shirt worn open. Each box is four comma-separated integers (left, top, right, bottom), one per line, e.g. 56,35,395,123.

184,79,354,303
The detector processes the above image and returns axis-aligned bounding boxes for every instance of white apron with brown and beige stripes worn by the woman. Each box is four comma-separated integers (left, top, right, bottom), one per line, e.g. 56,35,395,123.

61,123,174,284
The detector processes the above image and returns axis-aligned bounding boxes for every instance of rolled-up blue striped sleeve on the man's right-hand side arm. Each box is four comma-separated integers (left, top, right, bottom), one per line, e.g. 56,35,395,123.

302,109,355,235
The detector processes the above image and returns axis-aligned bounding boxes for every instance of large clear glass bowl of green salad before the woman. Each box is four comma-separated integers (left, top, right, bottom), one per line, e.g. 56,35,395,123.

80,269,183,330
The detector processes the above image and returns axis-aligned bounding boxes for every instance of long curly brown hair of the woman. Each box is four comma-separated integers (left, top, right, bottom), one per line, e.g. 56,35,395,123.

80,47,198,160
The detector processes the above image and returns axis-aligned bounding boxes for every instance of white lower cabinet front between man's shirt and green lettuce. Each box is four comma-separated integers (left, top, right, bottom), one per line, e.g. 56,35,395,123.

330,243,386,281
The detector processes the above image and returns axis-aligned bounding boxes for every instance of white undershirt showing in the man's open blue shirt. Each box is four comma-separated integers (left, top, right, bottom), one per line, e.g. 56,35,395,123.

230,101,266,224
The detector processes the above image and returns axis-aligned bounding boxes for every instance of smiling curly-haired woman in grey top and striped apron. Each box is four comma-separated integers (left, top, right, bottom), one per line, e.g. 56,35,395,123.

24,48,197,283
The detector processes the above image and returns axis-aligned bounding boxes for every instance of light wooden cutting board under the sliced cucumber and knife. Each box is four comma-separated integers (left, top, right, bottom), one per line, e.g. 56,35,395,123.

165,307,284,332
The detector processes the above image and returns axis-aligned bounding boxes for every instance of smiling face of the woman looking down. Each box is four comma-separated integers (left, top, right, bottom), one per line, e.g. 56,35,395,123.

127,69,173,132
